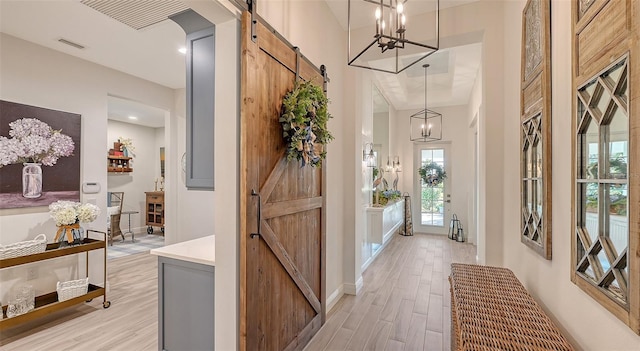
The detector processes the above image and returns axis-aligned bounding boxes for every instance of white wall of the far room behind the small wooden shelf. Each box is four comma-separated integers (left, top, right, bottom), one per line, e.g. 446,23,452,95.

105,120,164,234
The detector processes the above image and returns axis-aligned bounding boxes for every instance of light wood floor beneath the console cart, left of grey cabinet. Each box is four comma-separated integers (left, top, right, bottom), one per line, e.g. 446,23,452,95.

0,253,158,351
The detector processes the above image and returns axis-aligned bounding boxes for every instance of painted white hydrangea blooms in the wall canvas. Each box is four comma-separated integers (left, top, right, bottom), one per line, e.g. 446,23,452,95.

0,118,75,168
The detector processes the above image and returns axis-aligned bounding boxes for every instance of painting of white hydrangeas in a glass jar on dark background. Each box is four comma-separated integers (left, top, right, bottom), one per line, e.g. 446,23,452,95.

0,100,81,209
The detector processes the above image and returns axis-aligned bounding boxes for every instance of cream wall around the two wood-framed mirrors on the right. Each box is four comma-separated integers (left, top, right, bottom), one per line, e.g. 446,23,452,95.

500,0,640,351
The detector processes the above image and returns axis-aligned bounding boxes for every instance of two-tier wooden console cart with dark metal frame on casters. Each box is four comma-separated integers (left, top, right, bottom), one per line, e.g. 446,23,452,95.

0,229,111,330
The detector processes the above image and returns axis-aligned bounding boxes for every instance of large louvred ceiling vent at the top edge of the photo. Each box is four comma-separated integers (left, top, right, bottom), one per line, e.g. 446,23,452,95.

80,0,189,30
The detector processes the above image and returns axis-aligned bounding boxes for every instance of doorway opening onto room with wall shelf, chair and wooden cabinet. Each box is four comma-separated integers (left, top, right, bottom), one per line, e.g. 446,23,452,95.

106,96,169,259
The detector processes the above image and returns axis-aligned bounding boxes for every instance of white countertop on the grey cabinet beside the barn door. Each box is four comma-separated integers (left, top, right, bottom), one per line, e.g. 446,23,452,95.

151,235,216,266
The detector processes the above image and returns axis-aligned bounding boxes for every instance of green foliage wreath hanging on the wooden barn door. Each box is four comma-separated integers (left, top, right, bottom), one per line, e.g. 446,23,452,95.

280,81,333,167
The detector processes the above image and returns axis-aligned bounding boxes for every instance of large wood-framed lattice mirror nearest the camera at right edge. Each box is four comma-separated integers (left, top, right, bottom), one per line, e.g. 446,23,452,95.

571,0,640,334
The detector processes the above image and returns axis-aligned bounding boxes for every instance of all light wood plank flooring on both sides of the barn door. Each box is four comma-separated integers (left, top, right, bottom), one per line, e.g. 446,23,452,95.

0,234,476,351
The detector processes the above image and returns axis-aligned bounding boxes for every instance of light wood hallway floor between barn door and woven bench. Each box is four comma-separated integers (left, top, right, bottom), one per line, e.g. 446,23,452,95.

305,234,476,351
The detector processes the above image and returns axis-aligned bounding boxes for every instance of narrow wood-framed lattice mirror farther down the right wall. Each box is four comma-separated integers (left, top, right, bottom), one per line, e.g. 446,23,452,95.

520,0,551,260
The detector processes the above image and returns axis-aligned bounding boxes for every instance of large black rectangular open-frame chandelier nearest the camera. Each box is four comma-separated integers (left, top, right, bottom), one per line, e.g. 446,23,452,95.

347,0,440,74
